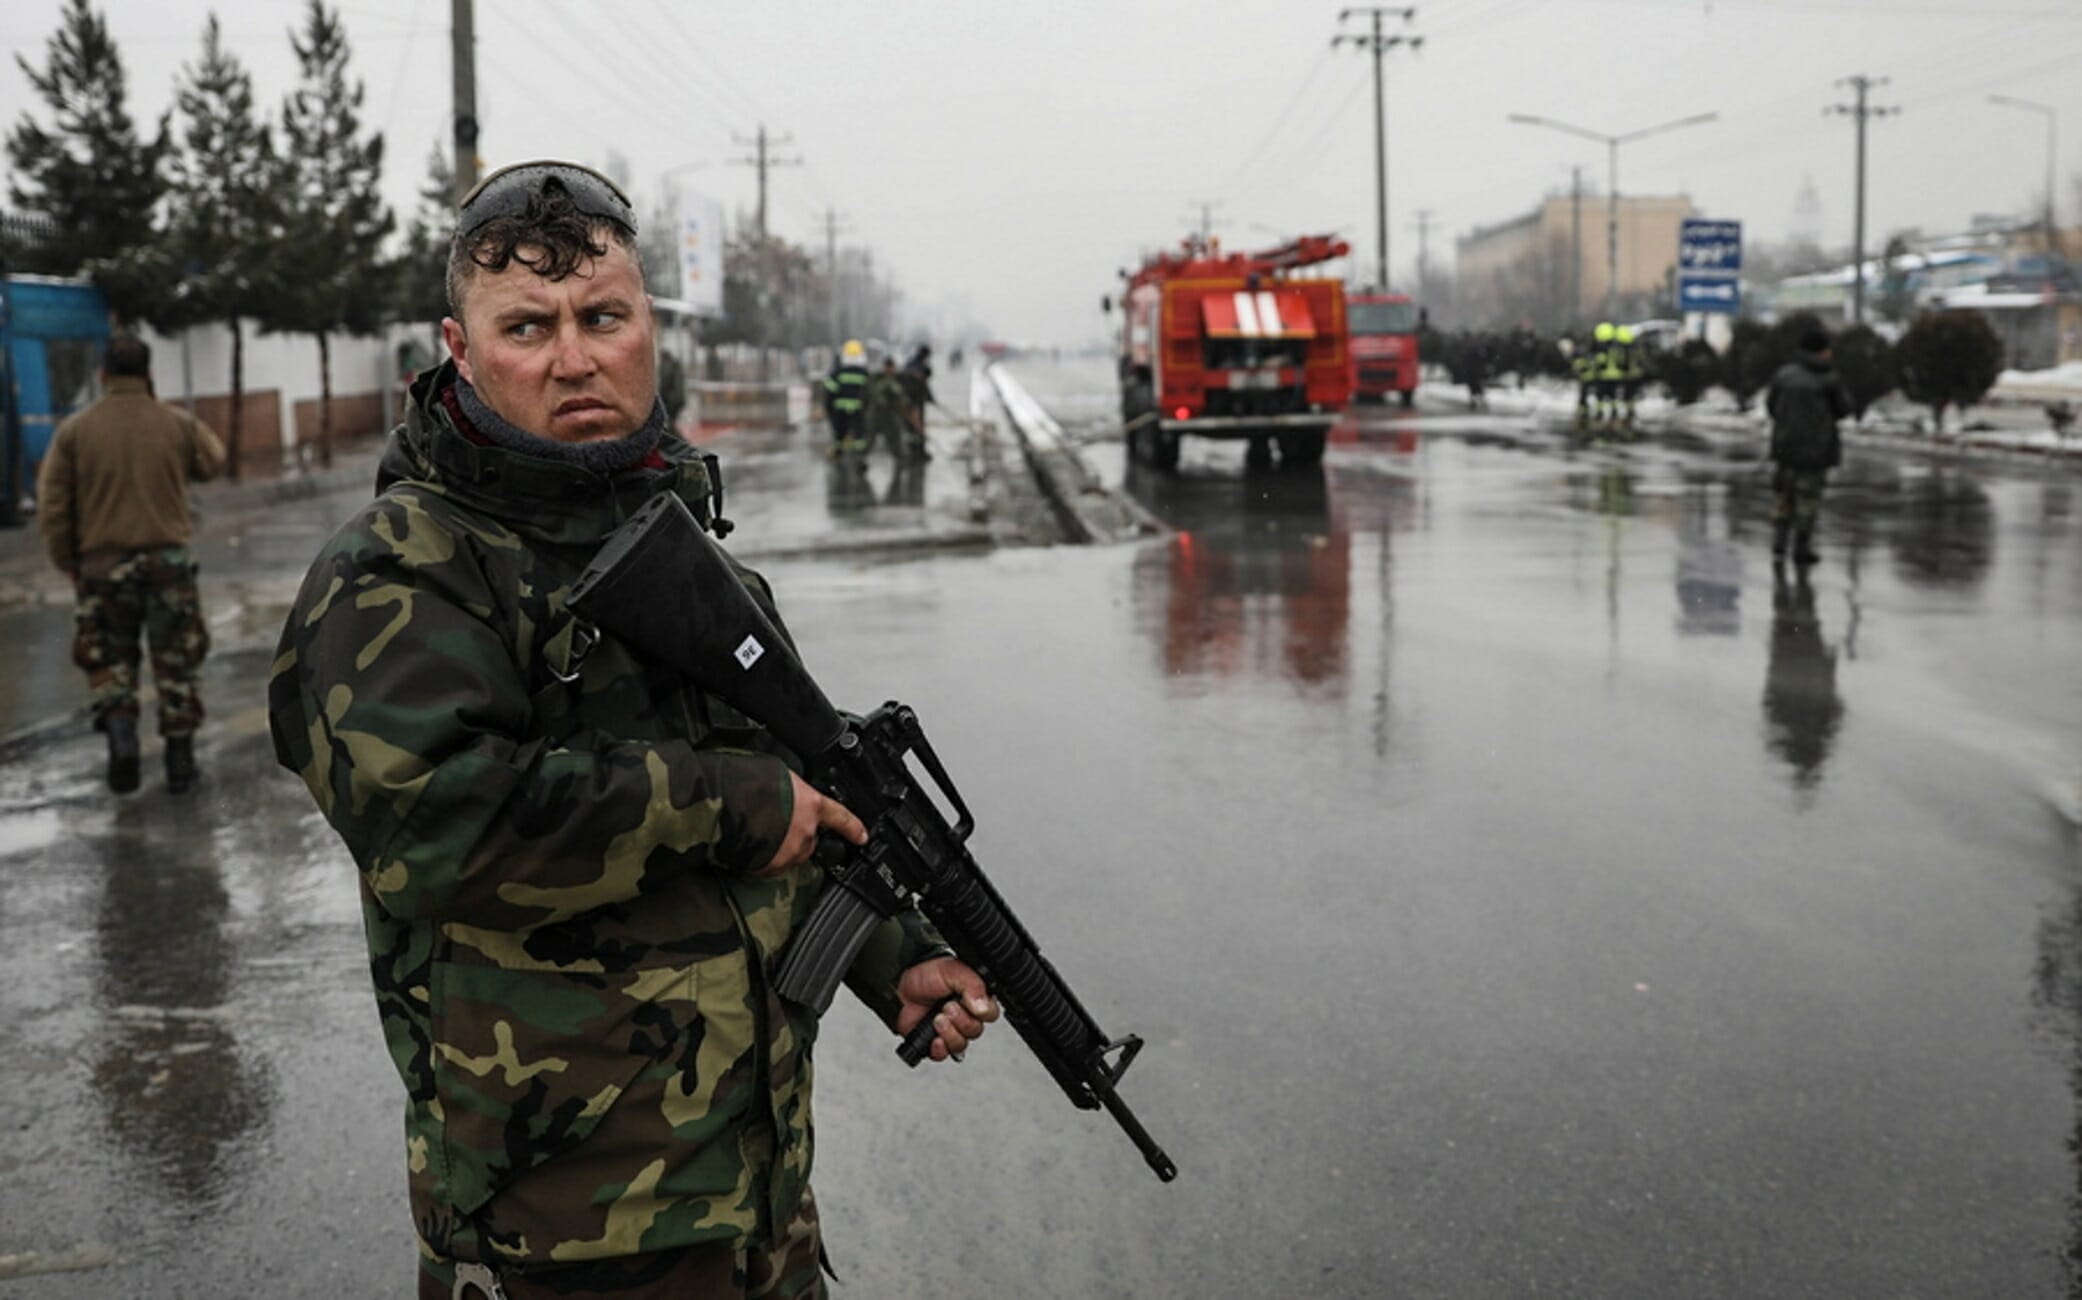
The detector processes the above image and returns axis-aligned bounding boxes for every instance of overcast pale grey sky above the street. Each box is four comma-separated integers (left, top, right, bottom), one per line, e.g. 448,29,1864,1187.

0,0,2082,342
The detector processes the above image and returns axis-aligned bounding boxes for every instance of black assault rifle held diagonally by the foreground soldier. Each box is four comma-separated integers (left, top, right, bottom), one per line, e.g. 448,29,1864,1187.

568,494,1178,1181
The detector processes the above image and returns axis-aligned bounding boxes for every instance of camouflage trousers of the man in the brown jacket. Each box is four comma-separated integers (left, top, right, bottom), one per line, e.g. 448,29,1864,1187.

73,546,210,735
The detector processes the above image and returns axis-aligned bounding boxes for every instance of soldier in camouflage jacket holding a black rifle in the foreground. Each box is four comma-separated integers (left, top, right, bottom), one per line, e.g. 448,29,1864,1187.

269,163,997,1300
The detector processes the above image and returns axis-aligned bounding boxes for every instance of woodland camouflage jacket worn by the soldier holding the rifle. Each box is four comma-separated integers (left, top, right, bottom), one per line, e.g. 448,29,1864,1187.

269,367,929,1265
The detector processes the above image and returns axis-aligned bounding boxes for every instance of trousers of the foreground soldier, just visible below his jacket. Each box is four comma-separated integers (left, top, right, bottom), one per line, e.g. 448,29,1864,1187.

418,1192,827,1300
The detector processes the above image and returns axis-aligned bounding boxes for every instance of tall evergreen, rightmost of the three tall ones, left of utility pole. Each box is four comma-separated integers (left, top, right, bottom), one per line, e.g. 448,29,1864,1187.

262,0,393,465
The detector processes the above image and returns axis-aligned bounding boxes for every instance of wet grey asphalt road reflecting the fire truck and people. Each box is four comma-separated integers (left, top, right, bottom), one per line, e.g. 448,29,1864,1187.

0,363,2082,1298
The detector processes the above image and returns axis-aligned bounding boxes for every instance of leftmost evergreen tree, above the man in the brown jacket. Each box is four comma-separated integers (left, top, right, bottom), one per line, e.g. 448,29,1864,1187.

6,0,169,321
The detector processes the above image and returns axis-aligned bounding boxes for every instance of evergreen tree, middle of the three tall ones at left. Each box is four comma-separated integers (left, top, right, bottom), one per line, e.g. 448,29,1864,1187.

160,13,281,479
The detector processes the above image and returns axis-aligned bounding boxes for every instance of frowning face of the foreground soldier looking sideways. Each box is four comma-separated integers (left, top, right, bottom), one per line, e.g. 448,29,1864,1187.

441,242,658,442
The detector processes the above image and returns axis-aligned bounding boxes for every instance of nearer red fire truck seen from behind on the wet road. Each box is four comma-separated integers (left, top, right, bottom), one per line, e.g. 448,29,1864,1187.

1108,235,1353,469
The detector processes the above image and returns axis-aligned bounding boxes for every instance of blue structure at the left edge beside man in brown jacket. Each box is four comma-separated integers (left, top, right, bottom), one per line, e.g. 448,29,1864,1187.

0,275,108,523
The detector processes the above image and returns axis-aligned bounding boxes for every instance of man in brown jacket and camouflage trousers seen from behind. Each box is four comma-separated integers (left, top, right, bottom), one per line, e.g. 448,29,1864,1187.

35,335,225,794
